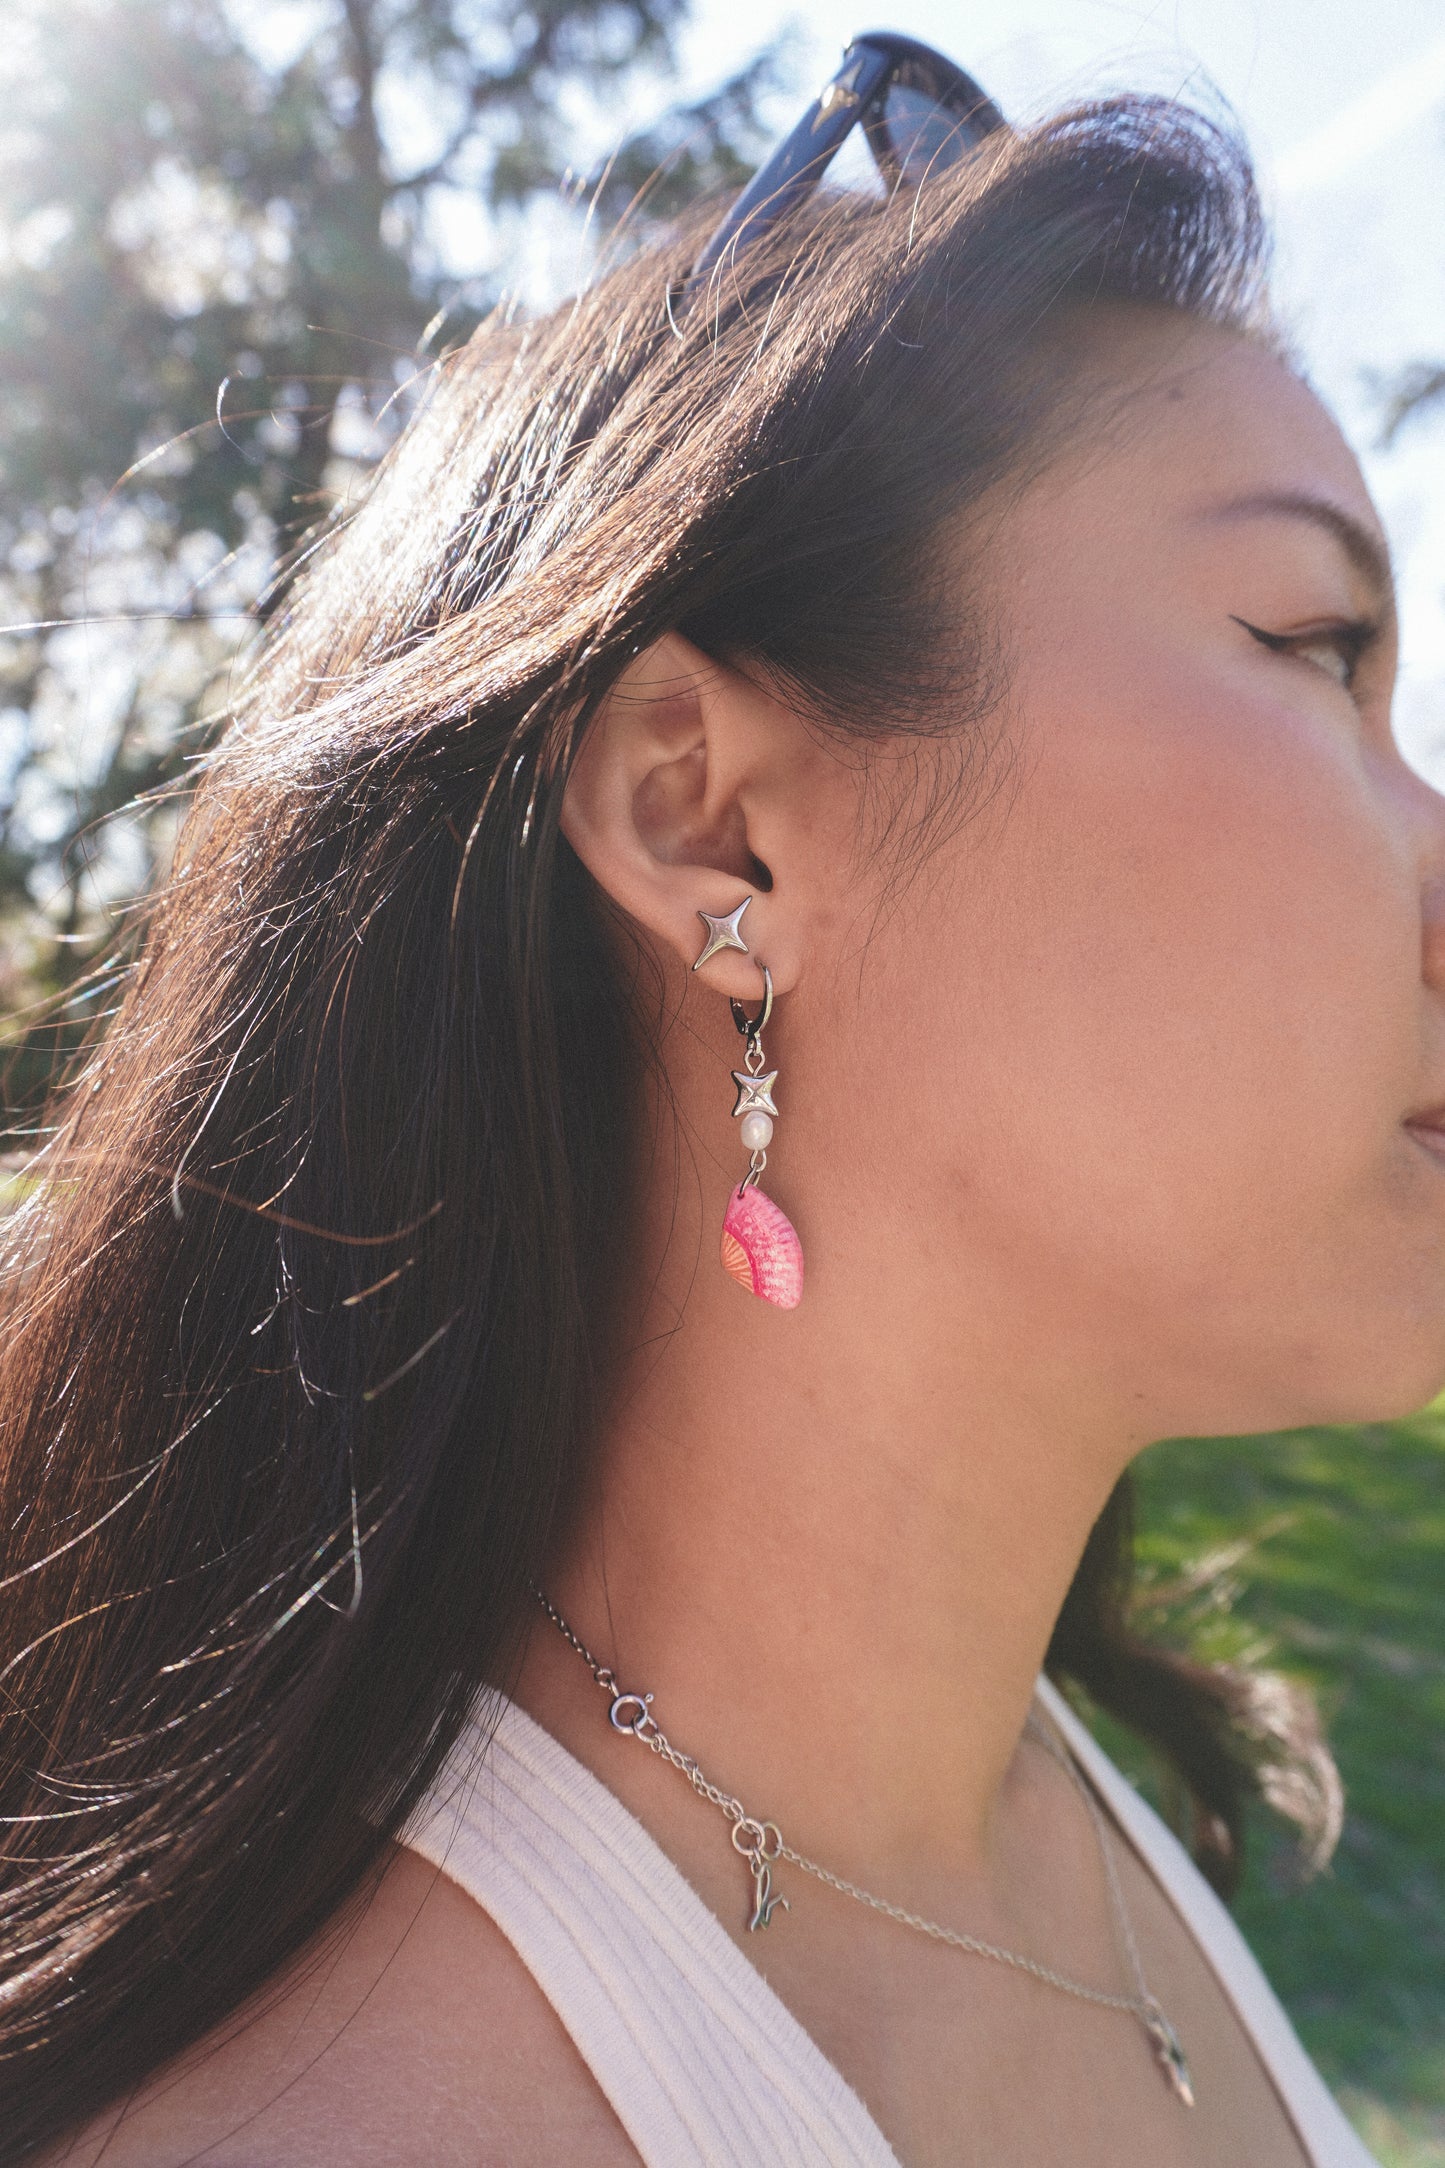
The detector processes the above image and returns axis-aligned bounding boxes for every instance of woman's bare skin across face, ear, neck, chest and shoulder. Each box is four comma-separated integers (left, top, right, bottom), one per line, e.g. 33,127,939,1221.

50,310,1445,2168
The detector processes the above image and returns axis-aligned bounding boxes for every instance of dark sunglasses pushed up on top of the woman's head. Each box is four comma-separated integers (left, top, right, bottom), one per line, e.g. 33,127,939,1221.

682,30,1007,304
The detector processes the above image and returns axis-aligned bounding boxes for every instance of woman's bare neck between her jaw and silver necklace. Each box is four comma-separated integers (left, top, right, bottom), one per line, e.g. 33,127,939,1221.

522,1188,1129,1890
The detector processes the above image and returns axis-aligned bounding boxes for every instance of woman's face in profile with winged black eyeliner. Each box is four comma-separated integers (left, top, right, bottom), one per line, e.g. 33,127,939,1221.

847,314,1445,1437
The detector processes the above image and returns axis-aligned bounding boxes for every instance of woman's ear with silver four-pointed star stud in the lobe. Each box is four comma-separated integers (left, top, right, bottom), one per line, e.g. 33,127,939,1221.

561,633,843,1002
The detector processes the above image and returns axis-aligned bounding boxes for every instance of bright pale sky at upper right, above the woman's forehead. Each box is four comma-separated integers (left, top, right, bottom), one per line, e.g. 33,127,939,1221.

662,0,1445,783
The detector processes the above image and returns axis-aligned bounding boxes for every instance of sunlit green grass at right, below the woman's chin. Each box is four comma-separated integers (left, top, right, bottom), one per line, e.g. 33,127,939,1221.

1111,1403,1445,2168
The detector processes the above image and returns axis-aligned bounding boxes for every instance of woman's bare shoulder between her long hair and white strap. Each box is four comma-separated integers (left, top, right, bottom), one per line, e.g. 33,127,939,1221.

43,1849,637,2168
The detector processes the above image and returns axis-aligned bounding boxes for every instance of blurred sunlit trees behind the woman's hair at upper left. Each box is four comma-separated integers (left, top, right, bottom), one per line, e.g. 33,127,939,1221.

0,0,792,1143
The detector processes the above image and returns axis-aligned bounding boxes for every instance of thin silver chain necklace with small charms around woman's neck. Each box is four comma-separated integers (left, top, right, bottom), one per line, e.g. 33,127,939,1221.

533,1587,1194,2107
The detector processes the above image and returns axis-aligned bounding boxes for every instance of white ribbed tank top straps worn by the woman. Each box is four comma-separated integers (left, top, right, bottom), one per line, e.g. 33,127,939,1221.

403,1680,1378,2168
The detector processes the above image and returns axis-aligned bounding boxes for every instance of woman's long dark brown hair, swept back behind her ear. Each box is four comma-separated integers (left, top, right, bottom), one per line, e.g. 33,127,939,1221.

0,102,1328,2161
